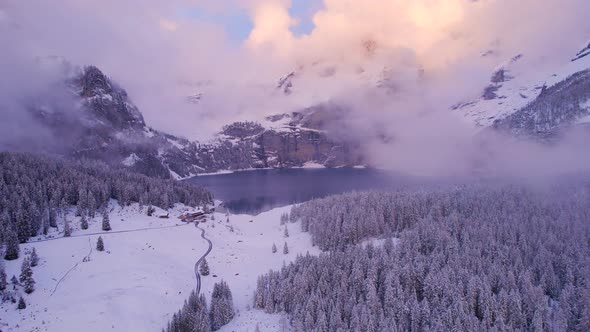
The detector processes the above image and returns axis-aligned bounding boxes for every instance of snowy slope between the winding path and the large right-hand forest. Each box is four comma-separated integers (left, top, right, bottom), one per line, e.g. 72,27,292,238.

202,206,319,332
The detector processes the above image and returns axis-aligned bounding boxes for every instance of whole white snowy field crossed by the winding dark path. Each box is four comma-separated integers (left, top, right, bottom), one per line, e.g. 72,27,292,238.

0,204,318,331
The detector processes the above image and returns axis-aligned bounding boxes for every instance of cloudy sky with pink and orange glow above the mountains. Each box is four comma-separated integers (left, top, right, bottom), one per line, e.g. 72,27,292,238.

0,0,590,176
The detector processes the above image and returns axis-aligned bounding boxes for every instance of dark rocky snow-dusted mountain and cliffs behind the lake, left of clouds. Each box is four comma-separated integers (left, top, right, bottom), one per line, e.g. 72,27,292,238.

8,64,360,179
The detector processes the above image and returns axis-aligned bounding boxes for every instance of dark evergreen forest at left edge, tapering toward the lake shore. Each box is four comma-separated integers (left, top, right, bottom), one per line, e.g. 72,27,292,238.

0,153,212,249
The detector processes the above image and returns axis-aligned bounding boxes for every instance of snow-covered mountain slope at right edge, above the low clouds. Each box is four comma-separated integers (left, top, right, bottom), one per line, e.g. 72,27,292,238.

452,45,590,136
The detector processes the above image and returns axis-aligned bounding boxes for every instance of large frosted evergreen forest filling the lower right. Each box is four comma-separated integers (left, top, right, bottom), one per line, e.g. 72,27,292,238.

255,184,590,332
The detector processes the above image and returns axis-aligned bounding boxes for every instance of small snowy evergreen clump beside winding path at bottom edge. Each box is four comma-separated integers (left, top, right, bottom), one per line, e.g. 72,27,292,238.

165,281,234,332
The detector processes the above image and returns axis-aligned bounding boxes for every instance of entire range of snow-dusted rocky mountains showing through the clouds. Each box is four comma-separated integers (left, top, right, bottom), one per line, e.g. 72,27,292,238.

5,41,590,179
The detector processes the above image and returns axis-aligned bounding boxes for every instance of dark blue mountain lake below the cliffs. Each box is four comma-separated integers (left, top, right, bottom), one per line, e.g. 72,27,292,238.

185,168,418,214
